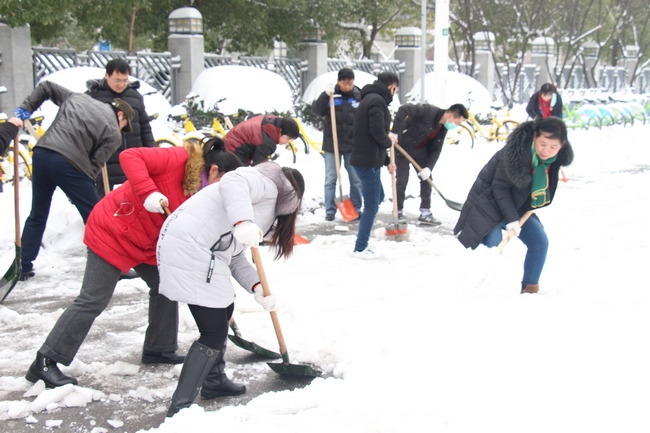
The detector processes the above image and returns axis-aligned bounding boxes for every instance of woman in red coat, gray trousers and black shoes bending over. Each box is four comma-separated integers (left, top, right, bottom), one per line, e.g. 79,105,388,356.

25,138,241,388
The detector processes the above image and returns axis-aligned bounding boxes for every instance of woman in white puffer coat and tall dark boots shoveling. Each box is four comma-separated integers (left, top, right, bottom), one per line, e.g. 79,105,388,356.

157,162,305,416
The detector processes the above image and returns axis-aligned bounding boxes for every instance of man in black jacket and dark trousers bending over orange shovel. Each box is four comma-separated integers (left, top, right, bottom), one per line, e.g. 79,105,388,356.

392,104,469,226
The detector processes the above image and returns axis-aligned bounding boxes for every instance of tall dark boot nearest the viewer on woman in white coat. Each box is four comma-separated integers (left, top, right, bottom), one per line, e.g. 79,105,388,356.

167,341,221,417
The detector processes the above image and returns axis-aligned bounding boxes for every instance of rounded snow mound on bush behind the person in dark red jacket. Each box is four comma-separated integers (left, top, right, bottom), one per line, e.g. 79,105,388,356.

191,65,293,115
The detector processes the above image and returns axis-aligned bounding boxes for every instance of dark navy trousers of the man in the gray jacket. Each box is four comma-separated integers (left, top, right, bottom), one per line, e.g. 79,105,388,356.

21,146,99,273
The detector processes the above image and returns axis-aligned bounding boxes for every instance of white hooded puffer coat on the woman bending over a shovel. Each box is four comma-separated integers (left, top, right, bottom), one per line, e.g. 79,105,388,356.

157,162,299,308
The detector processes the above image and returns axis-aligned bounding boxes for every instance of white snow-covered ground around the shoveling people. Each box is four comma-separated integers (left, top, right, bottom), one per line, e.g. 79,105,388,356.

0,73,650,433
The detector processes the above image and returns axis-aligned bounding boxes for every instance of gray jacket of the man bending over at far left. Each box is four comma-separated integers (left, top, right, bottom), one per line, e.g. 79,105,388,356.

20,81,122,181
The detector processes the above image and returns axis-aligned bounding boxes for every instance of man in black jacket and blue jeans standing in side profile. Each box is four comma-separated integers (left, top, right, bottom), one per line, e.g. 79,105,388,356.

350,72,399,253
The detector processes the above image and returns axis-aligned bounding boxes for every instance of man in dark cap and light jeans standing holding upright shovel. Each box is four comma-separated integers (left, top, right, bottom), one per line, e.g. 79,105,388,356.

312,68,361,221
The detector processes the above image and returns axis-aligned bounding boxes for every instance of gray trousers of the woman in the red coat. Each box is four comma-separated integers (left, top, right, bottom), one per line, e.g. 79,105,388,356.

39,249,178,365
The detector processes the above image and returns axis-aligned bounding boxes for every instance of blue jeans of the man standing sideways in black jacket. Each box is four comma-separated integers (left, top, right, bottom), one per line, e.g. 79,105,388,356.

354,166,384,251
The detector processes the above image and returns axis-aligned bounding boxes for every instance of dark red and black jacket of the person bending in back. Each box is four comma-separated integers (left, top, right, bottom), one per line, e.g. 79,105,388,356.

224,114,282,165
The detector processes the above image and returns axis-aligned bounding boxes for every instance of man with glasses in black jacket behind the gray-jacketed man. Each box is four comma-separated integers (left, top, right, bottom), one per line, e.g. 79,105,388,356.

86,58,156,198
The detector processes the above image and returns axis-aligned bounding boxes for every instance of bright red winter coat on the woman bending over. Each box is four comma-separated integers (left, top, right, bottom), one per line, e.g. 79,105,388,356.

84,147,203,272
